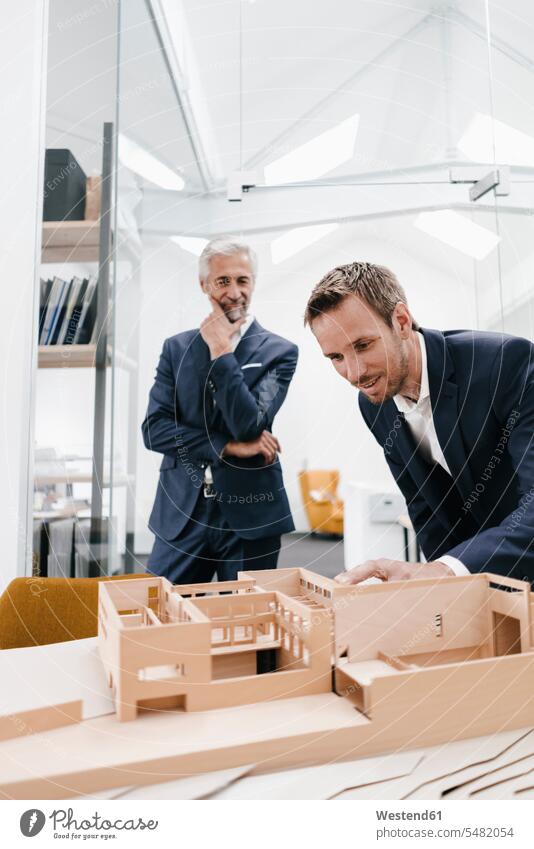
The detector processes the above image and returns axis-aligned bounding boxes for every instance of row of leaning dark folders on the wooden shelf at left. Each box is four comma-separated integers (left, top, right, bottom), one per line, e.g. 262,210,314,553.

39,277,97,345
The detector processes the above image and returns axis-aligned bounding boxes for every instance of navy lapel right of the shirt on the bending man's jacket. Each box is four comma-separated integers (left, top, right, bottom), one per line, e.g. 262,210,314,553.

423,330,476,512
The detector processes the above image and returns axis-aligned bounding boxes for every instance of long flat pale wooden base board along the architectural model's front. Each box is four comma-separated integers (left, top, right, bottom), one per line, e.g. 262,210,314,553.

0,693,531,799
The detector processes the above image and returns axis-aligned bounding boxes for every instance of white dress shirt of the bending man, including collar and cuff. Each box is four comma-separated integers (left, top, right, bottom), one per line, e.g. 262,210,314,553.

393,332,470,575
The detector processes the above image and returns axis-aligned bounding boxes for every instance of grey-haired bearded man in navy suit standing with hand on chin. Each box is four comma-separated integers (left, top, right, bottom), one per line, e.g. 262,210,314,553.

142,238,298,583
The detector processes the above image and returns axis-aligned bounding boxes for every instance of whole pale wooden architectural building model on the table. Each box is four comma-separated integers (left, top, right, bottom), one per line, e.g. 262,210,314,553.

0,569,534,799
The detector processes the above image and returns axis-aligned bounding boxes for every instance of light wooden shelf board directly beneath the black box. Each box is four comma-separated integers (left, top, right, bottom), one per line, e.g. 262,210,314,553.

41,219,100,262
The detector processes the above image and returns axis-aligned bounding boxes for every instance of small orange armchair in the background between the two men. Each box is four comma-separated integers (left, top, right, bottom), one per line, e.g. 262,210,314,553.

299,471,343,536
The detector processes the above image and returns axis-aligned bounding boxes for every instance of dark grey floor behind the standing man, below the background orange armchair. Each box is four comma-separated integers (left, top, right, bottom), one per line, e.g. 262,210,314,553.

134,533,343,578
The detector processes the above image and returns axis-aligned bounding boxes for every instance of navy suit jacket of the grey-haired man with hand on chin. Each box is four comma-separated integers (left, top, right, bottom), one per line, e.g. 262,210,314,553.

142,320,298,540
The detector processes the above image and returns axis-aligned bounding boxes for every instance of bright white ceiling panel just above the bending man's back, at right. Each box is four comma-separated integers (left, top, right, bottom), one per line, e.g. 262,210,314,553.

414,209,500,259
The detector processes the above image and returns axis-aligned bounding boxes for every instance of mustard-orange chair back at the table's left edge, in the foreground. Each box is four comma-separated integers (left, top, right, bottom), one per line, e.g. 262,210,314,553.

0,574,147,649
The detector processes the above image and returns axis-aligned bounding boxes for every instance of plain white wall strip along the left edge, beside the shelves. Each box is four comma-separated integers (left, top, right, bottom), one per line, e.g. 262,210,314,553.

0,0,48,589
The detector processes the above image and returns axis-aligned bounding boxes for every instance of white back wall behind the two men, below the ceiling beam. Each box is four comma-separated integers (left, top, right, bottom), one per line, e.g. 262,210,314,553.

136,221,475,553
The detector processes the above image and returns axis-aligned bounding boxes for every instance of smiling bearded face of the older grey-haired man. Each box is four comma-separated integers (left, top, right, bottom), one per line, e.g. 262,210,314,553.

200,252,254,323
